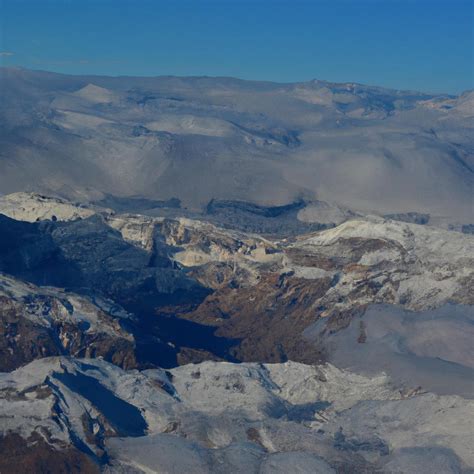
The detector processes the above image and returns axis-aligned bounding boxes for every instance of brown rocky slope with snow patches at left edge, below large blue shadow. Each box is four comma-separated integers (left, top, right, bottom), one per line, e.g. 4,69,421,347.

0,274,137,371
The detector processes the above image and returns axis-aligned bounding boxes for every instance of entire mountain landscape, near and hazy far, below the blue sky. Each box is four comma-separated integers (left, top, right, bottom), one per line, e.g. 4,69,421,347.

0,67,474,474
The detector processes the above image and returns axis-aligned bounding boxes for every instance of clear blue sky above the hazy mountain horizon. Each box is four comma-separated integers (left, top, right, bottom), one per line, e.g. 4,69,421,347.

0,0,474,93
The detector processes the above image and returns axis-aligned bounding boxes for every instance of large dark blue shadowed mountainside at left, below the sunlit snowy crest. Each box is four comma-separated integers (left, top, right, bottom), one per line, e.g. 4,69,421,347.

0,210,208,303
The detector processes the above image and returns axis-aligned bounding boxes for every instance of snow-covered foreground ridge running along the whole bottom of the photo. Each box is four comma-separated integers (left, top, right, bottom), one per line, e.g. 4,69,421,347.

0,357,474,473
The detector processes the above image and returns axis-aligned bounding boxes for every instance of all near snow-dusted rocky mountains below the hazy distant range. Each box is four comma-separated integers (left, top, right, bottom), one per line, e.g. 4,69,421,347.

0,194,474,474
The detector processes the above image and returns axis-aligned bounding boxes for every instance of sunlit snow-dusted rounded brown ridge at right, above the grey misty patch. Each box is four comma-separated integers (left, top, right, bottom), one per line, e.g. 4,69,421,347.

290,220,474,310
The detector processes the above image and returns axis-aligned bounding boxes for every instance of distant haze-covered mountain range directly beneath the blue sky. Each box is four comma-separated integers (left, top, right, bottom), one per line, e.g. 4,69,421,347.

0,68,474,224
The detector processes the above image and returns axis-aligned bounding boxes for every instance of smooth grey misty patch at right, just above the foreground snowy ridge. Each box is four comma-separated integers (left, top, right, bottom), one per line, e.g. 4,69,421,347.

305,305,474,398
